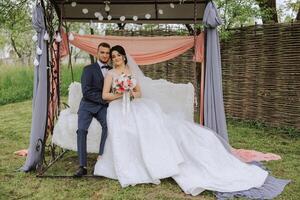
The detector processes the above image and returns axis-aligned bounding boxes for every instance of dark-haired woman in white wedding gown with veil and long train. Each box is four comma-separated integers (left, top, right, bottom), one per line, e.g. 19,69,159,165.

94,45,287,195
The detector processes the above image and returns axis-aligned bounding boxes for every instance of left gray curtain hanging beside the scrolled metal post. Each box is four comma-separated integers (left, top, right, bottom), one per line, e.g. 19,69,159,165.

21,4,47,172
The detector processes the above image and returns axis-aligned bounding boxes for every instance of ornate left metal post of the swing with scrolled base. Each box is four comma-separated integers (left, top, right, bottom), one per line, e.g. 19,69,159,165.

37,0,67,177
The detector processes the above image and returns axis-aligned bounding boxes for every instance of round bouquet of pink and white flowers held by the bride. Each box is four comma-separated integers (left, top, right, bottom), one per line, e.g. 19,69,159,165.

112,74,136,94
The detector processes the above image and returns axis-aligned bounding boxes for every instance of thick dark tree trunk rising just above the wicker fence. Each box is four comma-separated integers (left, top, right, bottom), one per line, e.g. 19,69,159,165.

256,0,278,24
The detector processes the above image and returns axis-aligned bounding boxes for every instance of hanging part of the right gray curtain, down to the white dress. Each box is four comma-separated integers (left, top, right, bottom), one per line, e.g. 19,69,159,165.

203,2,228,142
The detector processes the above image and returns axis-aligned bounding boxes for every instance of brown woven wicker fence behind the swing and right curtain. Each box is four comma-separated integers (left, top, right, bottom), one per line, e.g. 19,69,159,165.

108,23,300,129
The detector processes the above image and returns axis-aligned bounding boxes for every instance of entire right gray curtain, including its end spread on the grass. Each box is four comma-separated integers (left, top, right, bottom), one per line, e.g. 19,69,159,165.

203,1,290,200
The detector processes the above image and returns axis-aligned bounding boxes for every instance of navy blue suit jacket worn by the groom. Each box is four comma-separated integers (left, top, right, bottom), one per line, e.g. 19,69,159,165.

78,62,108,113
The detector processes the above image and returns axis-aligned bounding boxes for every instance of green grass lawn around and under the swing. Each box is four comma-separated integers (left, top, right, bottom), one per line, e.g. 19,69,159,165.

0,101,300,200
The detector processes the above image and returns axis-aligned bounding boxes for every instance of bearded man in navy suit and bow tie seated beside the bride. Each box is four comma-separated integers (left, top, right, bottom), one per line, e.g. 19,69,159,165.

74,42,111,177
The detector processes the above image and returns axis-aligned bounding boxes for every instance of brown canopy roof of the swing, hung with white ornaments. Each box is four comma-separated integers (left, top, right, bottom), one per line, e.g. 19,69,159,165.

48,0,207,24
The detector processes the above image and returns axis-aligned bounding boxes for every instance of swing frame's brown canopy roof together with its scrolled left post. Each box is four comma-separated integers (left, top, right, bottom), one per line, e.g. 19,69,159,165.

31,0,209,175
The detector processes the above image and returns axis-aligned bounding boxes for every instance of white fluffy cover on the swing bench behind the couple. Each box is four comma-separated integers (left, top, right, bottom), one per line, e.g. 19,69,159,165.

52,79,194,153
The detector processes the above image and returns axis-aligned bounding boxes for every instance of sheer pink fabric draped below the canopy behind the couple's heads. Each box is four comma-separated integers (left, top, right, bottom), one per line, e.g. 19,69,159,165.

61,33,204,65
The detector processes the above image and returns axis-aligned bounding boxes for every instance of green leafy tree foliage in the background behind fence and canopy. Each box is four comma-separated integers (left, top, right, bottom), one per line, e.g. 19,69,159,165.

0,0,300,58
